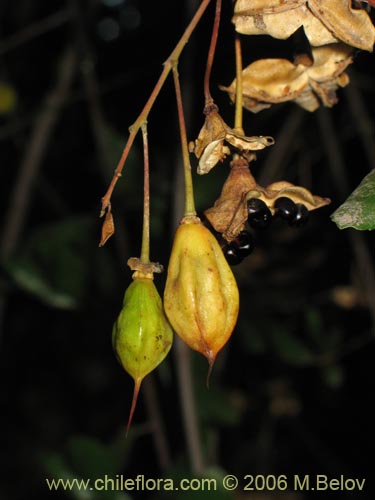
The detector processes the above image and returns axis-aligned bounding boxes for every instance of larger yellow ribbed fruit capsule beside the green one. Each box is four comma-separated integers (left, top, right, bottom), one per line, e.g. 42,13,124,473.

164,216,239,375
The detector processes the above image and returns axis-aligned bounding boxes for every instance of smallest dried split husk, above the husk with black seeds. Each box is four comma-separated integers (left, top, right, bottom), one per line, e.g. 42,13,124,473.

190,106,274,175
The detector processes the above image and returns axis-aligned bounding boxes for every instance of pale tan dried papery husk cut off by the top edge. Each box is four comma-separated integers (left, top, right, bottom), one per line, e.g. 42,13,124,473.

232,0,375,52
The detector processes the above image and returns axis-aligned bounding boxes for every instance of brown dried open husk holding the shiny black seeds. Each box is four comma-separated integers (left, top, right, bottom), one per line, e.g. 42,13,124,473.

204,158,331,242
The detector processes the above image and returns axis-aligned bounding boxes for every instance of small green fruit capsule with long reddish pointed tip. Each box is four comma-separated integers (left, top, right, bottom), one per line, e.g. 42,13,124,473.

112,272,173,432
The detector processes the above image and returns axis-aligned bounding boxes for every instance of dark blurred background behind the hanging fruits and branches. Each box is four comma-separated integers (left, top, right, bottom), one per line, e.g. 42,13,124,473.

0,0,375,500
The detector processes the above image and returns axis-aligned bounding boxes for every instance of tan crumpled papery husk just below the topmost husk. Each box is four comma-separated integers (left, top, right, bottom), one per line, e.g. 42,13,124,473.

220,43,353,113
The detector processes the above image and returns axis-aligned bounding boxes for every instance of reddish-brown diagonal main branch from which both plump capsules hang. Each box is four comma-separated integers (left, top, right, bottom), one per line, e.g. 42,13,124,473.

100,0,211,216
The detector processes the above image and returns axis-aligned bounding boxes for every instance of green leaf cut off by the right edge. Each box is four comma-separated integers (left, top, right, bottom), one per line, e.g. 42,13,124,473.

331,169,375,231
